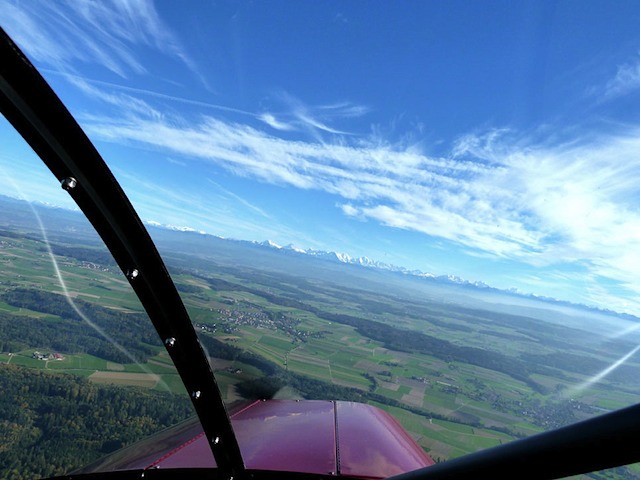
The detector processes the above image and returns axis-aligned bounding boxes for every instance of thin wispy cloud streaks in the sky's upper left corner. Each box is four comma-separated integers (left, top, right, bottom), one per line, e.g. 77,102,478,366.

0,0,198,78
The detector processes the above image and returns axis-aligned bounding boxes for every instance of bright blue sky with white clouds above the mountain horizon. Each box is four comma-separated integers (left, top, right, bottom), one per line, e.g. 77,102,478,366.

0,0,640,314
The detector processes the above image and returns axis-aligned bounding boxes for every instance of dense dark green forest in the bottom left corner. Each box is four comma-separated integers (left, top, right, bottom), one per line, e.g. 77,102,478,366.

0,364,192,480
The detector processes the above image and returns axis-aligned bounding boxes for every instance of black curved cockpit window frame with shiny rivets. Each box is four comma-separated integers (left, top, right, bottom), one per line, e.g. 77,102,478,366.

0,29,244,478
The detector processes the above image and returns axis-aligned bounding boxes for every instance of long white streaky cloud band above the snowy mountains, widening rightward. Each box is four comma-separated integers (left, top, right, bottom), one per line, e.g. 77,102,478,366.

81,107,640,312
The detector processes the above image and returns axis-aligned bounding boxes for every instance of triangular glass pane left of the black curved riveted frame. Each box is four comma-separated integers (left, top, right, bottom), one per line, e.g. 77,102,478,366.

0,115,193,479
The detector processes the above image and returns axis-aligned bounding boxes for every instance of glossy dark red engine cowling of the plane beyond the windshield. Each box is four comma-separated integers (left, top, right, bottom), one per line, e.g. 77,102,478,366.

92,400,434,478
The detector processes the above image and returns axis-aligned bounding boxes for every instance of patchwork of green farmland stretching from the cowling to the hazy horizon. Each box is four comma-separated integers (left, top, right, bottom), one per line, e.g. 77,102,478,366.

0,226,640,480
